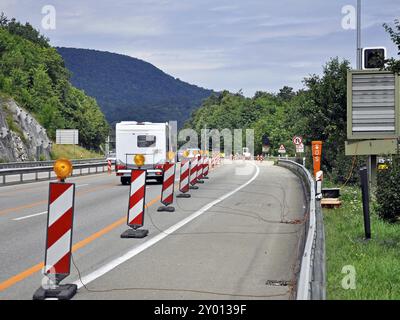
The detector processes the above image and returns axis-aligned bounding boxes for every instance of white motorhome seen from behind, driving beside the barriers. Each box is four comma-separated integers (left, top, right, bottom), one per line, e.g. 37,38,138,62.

115,121,170,184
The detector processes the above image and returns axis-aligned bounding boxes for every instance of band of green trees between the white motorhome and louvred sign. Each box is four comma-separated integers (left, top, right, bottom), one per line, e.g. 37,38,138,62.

186,58,352,180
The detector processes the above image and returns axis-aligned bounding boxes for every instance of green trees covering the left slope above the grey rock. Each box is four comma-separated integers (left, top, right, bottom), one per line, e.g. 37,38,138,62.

0,14,109,148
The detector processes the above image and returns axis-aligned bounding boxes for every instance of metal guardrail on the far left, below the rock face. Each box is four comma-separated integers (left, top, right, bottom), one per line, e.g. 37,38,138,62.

0,160,107,185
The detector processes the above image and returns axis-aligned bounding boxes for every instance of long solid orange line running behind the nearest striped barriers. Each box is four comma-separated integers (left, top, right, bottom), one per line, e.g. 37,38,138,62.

0,196,161,291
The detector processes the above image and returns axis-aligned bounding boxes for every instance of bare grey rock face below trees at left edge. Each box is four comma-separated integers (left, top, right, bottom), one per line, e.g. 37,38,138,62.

0,97,51,162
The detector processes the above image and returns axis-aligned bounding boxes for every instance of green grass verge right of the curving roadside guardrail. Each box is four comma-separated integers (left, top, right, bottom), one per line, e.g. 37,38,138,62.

324,186,400,300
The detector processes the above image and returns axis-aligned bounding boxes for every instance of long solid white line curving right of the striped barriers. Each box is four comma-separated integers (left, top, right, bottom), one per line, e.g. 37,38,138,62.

74,164,260,289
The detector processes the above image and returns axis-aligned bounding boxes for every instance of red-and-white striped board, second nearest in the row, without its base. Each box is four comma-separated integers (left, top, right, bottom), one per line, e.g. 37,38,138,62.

128,169,146,229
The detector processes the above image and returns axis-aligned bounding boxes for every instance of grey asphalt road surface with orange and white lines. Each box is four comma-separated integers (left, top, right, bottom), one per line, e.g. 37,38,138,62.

0,161,305,299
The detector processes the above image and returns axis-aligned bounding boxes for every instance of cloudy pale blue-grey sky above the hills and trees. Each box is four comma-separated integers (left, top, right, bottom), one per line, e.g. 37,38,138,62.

0,0,400,96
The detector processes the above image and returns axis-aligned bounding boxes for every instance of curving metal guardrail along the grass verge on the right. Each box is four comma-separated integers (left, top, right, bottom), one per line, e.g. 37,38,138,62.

278,159,326,300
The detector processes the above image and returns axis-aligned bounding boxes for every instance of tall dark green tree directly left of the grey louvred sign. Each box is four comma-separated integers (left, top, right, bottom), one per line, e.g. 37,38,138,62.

299,58,352,181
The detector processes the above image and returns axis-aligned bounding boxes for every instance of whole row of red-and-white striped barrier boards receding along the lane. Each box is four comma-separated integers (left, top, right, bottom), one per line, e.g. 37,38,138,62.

33,155,222,300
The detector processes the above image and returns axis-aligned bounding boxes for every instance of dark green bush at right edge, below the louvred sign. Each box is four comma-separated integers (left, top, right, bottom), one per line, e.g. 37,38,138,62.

376,156,400,222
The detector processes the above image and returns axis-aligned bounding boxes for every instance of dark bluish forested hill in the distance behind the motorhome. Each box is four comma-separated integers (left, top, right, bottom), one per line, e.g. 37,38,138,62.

57,48,212,125
